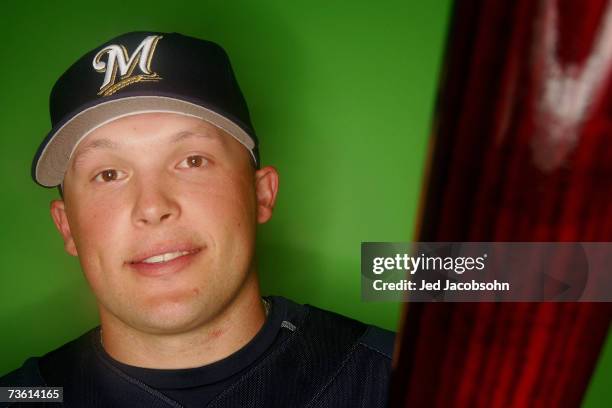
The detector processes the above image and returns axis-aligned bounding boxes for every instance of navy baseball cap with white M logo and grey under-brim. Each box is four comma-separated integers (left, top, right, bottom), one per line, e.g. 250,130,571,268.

32,32,259,187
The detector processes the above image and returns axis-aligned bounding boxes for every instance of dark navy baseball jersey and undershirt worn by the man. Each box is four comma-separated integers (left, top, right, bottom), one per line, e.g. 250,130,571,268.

0,296,394,408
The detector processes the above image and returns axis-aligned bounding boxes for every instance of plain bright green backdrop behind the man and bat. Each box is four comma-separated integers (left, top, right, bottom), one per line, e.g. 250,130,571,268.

0,0,612,406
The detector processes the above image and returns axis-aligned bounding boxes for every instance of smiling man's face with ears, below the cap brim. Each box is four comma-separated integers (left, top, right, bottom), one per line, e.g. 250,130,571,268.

52,113,278,333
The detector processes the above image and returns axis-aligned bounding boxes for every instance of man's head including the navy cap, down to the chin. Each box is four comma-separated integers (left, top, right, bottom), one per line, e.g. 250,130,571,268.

32,33,278,333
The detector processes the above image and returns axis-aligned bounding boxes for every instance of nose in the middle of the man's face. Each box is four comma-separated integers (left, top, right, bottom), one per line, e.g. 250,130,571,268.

132,178,180,226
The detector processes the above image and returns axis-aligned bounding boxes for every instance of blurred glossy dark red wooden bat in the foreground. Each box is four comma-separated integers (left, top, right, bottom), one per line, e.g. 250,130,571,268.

391,0,612,407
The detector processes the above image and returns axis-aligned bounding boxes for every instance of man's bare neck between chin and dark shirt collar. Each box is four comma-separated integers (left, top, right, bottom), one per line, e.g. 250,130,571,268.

100,276,266,369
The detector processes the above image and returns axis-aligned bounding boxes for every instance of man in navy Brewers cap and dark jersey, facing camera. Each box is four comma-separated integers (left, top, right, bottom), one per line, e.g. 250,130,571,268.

0,32,393,407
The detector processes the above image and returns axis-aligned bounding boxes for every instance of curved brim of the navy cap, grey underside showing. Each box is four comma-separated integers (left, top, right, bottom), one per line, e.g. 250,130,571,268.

33,95,257,187
